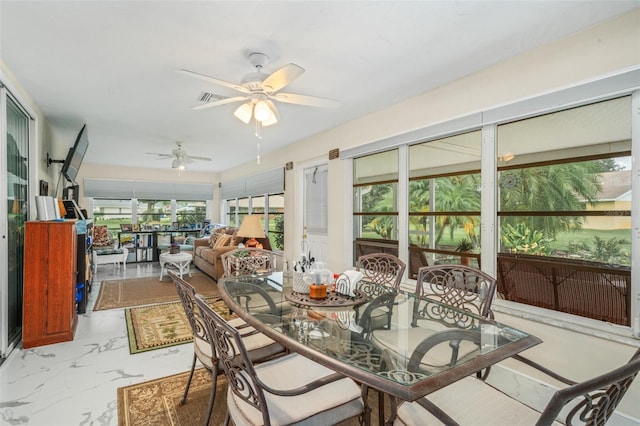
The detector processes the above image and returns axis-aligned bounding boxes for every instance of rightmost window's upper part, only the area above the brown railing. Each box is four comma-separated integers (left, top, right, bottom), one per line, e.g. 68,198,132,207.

497,96,631,266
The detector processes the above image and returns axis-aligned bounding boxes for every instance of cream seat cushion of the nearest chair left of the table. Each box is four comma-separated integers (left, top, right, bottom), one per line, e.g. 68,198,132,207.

227,354,364,426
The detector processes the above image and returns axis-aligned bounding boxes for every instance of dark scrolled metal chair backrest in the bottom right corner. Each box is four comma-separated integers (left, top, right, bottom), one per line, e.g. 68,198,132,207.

537,349,640,426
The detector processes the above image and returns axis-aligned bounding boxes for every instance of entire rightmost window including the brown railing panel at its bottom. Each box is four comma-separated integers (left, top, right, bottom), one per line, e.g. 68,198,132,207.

497,96,632,325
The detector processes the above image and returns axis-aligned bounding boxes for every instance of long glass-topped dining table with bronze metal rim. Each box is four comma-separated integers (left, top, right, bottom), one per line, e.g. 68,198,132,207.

218,272,541,424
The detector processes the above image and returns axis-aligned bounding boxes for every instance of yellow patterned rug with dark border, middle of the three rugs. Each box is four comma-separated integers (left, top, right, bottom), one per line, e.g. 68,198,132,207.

124,297,235,354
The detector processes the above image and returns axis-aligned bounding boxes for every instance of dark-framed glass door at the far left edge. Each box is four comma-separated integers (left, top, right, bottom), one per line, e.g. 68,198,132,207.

0,96,30,358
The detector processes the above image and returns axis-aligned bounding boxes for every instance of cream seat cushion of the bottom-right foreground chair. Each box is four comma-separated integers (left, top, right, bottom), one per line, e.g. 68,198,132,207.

394,377,561,426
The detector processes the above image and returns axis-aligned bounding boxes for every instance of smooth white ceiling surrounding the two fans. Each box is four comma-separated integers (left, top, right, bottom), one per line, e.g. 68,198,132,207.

0,0,640,172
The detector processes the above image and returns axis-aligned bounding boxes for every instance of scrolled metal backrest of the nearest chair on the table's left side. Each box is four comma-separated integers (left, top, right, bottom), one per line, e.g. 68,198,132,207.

195,294,270,425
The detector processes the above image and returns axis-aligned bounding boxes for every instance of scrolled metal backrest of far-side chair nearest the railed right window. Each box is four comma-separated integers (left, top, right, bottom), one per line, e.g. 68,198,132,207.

414,265,497,324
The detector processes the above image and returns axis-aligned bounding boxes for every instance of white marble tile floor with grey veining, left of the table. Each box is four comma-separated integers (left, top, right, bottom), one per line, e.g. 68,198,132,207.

0,263,193,426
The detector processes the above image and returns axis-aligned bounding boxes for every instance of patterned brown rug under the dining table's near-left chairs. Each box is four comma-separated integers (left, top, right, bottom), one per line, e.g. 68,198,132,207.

118,369,380,426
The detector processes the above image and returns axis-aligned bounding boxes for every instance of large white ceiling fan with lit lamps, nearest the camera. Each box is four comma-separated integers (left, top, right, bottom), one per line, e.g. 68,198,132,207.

178,52,340,126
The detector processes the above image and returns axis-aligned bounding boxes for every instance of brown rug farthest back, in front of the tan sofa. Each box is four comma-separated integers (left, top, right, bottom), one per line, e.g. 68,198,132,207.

93,273,218,311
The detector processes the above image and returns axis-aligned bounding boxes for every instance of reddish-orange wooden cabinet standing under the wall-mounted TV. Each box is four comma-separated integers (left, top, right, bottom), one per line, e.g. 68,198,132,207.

22,221,78,348
